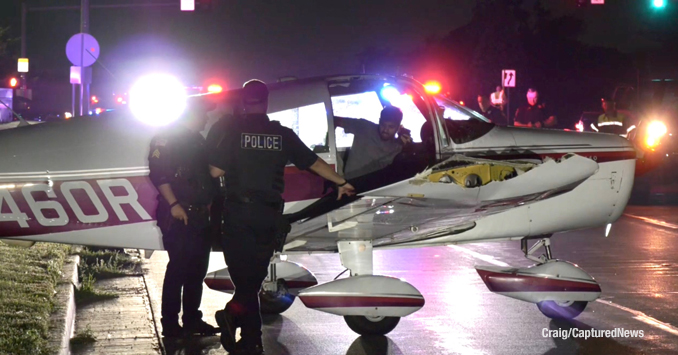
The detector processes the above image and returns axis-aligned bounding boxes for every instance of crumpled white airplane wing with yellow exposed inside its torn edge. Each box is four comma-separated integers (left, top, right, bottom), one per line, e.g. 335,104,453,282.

284,155,598,252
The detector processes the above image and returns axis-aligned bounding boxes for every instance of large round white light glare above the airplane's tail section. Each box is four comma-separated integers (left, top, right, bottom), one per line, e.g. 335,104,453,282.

129,74,186,126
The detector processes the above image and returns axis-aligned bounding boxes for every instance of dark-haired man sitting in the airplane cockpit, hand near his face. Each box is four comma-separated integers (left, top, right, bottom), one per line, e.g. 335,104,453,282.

334,106,412,179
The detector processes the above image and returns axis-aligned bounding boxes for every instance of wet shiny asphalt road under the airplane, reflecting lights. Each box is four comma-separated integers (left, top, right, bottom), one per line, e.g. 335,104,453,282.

145,207,678,355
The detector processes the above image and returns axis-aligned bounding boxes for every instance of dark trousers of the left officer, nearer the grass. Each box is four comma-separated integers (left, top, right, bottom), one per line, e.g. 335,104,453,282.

158,209,211,327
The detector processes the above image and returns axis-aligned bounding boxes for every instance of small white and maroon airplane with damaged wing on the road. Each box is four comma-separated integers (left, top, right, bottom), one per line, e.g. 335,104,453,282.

0,74,659,335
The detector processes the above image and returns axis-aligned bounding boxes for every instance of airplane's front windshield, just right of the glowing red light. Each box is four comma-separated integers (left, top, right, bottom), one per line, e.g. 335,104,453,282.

435,96,494,144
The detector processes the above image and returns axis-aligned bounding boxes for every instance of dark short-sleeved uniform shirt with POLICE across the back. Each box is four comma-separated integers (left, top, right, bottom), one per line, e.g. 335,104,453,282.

208,114,318,202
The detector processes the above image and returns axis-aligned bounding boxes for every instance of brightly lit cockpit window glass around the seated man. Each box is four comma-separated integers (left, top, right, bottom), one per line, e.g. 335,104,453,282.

332,91,426,148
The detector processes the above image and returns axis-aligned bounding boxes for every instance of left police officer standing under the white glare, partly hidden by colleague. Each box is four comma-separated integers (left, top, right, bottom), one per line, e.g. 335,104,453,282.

148,101,216,337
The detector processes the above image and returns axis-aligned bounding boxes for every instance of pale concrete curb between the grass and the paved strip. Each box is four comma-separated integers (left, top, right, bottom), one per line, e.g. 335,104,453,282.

49,255,80,355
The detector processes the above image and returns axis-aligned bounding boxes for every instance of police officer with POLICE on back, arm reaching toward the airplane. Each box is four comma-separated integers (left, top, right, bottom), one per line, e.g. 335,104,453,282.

208,80,354,354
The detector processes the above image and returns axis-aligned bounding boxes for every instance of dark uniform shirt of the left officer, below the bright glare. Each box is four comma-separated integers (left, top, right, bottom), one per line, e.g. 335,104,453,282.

148,125,216,205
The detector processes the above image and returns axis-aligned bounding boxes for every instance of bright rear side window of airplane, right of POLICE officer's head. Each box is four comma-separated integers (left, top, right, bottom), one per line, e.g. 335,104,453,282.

268,102,330,153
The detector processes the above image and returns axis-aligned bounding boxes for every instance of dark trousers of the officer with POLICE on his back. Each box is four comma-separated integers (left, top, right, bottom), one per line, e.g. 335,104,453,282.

222,201,280,345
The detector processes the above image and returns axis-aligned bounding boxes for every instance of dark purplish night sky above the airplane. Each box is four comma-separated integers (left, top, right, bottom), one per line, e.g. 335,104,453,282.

0,0,676,93
